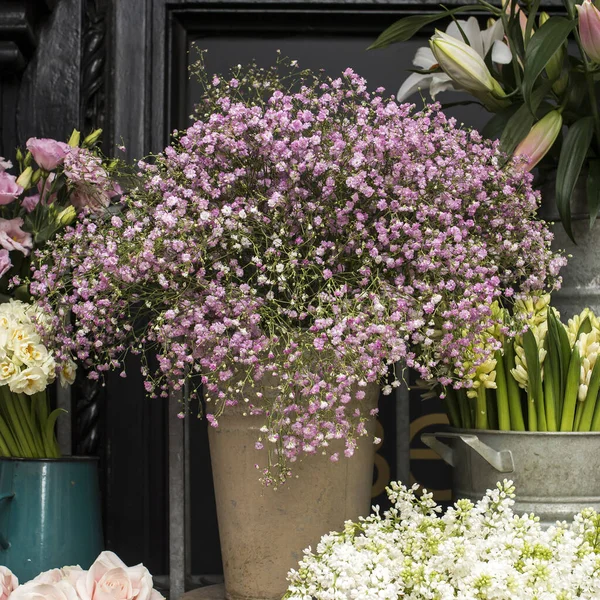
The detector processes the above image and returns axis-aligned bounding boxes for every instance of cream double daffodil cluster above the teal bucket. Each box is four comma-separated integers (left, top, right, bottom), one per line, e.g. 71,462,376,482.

0,300,76,396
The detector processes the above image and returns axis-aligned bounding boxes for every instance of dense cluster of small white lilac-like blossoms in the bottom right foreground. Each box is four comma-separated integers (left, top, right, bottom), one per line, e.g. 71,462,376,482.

284,481,600,600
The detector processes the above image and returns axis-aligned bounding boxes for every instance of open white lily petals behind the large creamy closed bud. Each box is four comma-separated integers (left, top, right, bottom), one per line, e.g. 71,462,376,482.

397,17,512,102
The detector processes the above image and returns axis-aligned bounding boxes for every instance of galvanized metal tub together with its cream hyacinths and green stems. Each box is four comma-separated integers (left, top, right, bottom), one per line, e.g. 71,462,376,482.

422,295,600,526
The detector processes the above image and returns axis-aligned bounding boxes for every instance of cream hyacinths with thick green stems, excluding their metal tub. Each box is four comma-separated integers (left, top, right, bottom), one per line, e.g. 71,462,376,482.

432,295,600,432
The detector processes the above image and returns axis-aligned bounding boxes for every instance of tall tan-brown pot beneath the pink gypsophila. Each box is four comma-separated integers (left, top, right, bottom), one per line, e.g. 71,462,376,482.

209,385,379,600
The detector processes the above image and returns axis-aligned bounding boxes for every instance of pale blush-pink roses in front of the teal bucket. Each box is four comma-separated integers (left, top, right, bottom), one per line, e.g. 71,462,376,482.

0,552,164,600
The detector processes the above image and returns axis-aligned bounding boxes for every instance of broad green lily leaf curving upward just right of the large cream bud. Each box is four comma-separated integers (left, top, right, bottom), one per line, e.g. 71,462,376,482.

523,17,576,112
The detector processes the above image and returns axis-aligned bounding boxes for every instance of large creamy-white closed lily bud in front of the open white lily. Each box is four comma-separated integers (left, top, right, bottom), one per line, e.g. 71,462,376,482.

429,30,505,97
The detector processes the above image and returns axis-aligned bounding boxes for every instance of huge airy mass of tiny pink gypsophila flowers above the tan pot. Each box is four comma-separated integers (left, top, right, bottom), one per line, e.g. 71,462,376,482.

31,57,564,483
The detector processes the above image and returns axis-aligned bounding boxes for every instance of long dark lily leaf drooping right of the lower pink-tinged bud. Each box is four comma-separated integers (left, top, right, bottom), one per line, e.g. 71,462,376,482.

548,117,594,242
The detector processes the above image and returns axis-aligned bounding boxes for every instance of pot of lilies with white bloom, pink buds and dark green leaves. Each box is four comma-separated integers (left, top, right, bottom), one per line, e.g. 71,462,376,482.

372,0,600,314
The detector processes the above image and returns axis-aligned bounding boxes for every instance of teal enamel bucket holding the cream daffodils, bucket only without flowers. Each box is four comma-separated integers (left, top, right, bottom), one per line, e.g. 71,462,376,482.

0,457,103,583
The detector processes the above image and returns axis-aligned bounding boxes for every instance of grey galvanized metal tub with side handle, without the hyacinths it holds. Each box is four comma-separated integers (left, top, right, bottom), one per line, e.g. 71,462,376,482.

421,429,600,526
